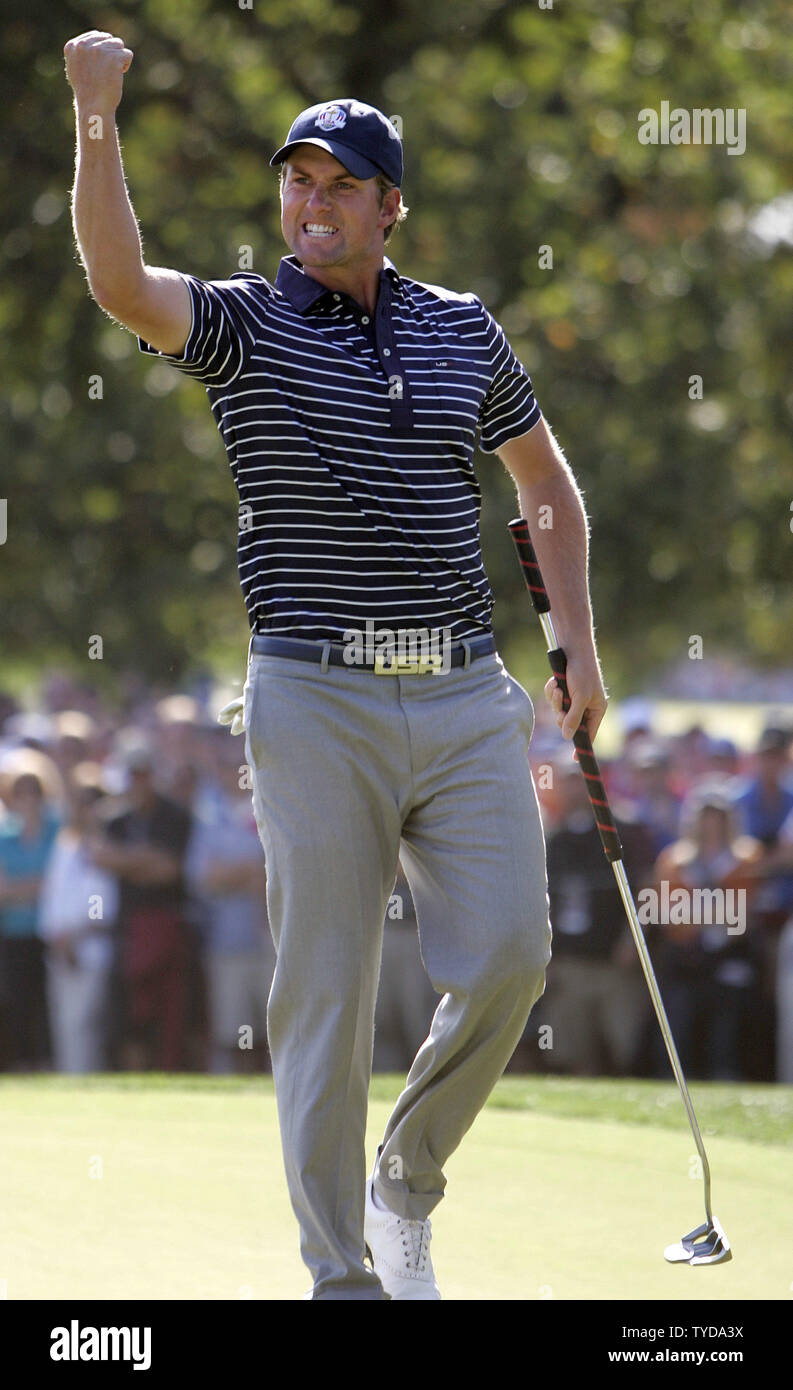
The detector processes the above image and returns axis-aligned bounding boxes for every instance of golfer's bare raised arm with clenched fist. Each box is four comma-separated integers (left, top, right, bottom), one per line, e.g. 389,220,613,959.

64,29,192,356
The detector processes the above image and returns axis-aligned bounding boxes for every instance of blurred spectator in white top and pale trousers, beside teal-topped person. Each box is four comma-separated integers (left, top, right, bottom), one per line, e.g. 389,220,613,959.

39,762,118,1072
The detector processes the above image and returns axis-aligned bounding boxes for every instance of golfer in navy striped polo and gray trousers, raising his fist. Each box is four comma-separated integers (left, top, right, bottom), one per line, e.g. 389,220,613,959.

65,31,607,1300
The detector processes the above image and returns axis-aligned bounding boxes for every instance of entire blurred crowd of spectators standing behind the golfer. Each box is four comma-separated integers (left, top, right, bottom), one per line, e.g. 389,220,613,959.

0,674,793,1083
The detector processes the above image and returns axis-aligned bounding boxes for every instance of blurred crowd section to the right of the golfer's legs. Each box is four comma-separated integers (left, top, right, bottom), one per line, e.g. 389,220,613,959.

524,706,793,1083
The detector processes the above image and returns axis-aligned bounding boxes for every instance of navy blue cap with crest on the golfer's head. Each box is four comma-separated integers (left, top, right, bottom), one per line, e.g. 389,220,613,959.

269,97,403,188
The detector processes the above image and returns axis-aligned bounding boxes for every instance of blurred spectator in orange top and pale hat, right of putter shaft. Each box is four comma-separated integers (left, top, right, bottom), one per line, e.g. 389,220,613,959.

656,781,762,1081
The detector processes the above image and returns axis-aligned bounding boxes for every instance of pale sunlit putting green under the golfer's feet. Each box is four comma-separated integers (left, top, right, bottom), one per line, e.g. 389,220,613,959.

0,1076,793,1301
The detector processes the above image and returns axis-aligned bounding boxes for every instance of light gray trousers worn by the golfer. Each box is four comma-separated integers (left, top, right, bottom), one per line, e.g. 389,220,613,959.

244,644,550,1300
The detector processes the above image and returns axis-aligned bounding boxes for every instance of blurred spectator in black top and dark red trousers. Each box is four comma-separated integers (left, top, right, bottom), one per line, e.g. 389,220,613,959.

90,738,192,1072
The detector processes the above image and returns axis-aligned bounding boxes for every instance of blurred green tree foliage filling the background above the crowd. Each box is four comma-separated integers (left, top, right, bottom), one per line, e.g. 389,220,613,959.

0,0,793,692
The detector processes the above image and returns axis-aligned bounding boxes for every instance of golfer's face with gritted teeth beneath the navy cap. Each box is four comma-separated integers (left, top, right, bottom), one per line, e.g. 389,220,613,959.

281,145,397,268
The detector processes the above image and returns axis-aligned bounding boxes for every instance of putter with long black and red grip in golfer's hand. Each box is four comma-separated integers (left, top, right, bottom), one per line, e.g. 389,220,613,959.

508,517,732,1265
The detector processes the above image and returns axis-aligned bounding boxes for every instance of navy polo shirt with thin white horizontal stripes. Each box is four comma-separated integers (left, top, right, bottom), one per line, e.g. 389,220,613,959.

137,256,540,641
